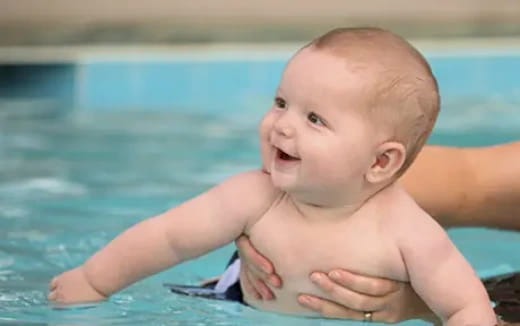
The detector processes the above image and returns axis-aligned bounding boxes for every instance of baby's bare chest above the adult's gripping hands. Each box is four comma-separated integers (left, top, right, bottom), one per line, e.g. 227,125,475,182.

246,204,408,284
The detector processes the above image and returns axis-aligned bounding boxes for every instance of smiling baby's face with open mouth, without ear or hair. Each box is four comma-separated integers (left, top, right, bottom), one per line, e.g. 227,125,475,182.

260,48,378,202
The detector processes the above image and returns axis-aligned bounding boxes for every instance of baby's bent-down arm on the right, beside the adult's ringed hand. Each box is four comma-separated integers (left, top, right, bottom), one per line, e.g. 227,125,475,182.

398,212,497,326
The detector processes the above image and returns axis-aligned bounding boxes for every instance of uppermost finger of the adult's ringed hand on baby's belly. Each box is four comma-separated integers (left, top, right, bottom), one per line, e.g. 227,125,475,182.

327,269,400,296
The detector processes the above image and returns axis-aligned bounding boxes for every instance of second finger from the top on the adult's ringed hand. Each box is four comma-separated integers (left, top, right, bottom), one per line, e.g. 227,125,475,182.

311,272,387,311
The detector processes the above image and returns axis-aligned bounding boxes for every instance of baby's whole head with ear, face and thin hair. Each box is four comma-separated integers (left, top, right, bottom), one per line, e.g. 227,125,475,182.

260,28,440,204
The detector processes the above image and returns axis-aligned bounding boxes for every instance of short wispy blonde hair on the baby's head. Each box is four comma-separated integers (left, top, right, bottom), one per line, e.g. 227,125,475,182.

305,27,440,177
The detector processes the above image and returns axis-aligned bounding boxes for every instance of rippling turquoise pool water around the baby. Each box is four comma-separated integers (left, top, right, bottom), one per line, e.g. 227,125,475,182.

0,47,520,325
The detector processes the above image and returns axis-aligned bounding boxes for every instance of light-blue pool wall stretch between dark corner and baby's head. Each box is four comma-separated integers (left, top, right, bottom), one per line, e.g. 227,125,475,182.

81,61,285,112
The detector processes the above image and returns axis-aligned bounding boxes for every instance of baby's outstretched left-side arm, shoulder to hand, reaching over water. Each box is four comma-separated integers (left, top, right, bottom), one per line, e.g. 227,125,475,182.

49,171,274,303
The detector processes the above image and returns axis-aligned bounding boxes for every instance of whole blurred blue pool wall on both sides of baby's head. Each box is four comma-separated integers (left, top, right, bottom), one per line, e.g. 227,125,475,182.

0,46,520,112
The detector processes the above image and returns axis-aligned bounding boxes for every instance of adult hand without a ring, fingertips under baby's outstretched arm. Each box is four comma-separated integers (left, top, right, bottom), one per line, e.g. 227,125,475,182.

235,235,282,300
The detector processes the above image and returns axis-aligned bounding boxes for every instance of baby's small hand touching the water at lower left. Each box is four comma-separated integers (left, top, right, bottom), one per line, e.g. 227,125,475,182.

47,266,106,303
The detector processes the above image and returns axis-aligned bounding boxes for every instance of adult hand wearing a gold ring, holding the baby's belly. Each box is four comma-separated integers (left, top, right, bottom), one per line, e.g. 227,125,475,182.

298,269,439,323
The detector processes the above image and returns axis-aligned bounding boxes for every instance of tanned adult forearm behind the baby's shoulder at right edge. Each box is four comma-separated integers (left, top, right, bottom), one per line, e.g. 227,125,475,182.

400,142,520,229
